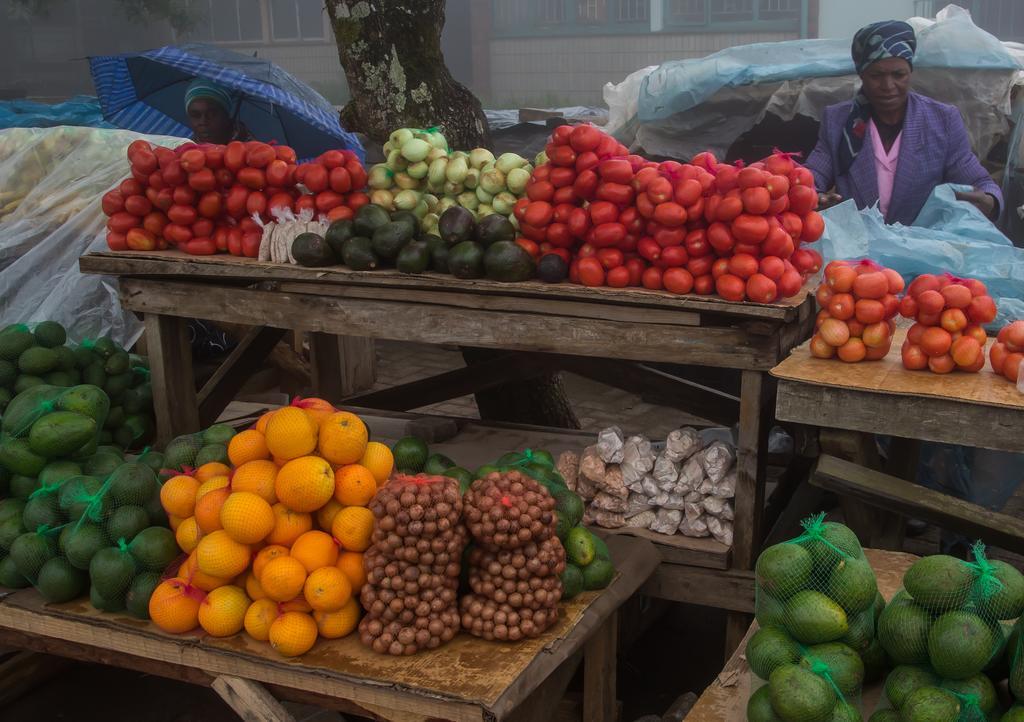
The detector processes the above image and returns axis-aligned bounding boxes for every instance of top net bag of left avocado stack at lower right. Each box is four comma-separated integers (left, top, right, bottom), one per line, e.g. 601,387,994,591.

755,514,883,675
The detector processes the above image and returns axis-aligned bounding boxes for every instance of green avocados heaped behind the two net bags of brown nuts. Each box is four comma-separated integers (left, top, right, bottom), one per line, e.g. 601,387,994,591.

391,436,615,600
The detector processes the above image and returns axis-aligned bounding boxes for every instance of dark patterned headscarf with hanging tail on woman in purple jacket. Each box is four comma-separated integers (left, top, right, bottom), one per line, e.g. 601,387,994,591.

839,20,918,175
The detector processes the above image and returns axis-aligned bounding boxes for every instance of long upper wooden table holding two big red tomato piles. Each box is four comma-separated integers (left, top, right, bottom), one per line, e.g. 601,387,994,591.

80,252,813,647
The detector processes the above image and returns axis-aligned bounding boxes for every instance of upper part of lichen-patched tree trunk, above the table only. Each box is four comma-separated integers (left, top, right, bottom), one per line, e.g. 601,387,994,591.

327,0,490,150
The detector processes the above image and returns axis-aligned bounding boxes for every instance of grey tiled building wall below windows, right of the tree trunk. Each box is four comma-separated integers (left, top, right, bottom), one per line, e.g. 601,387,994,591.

486,33,799,108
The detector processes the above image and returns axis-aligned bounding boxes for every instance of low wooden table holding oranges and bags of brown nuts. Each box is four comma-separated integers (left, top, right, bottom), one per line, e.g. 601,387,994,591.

0,537,658,722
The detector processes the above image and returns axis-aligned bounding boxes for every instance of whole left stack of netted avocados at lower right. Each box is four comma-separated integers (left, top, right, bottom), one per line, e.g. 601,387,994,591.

746,516,886,722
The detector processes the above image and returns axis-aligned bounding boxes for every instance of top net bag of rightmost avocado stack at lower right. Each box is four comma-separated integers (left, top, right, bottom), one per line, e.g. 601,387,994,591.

878,542,1024,680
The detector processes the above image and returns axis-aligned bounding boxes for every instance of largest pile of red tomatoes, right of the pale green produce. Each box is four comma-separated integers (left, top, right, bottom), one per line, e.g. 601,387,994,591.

514,125,824,303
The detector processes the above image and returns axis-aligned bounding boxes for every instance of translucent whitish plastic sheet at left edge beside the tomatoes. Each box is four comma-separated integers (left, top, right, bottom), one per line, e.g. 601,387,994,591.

0,126,183,347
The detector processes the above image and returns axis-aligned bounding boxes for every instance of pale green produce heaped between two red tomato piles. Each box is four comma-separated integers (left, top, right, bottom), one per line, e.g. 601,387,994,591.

367,128,534,230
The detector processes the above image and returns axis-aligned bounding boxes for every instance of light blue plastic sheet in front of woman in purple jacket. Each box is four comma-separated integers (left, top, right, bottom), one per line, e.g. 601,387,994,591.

819,185,1024,328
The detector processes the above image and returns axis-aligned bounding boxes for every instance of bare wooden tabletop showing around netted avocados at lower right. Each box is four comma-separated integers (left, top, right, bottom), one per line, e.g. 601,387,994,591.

685,549,918,722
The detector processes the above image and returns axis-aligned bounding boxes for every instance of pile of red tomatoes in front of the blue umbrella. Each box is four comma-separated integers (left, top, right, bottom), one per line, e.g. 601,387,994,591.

102,140,370,258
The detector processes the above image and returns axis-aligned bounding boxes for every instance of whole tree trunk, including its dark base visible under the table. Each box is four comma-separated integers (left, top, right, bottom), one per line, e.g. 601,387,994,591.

327,0,580,428
